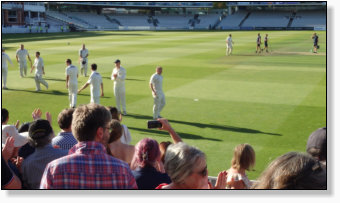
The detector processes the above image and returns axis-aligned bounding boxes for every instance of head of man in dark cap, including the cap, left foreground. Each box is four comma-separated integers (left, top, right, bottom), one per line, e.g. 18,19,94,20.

28,119,53,147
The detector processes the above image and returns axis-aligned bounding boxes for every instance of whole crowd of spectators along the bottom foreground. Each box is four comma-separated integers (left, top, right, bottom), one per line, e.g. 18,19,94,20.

1,103,327,189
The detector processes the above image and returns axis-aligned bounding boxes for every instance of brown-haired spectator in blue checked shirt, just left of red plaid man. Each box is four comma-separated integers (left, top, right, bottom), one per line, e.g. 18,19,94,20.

52,108,77,150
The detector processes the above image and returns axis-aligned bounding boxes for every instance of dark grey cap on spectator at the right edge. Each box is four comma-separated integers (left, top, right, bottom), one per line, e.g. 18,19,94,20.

306,128,327,151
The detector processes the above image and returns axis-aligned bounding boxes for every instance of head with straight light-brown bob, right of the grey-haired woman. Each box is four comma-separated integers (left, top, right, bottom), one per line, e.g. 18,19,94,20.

231,144,255,170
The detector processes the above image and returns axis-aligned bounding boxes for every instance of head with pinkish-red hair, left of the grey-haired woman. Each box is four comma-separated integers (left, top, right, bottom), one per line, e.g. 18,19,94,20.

131,138,161,170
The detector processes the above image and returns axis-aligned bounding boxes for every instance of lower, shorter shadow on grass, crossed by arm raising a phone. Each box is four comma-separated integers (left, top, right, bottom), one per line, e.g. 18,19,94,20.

129,125,222,141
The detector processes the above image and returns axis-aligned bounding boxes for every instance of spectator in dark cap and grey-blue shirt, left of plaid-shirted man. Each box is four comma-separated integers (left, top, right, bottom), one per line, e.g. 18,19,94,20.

21,119,67,189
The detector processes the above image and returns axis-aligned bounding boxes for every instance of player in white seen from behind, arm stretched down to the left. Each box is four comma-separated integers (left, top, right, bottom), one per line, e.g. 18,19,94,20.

78,63,104,104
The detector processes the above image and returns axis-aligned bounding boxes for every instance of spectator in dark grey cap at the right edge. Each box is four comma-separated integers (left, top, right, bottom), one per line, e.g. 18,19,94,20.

306,127,327,169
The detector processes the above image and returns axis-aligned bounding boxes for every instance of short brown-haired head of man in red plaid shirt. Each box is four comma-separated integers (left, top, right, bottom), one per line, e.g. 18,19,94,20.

72,103,111,144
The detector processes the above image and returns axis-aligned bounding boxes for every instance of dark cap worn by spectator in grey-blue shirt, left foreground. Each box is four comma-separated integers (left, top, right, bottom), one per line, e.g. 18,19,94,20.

28,119,53,139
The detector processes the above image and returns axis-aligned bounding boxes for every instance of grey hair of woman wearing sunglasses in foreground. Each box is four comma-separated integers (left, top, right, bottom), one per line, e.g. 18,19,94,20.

164,142,205,184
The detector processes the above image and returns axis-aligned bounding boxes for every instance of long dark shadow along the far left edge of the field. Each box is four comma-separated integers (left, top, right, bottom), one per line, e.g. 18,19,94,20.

2,32,148,43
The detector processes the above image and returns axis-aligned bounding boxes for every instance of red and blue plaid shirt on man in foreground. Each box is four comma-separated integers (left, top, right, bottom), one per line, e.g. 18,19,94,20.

40,142,137,189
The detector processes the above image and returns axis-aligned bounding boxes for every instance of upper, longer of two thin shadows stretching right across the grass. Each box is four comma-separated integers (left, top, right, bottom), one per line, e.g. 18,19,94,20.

126,114,282,136
